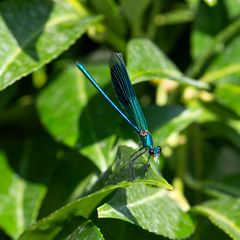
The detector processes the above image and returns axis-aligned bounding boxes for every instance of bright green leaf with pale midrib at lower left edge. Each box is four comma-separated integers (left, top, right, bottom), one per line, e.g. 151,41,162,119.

0,152,46,238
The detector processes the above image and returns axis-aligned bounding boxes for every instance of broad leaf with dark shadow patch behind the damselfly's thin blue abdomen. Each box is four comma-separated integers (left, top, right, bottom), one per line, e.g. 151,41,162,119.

37,65,120,171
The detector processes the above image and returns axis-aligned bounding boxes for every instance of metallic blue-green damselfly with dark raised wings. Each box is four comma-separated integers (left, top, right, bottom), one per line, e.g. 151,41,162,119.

77,53,161,164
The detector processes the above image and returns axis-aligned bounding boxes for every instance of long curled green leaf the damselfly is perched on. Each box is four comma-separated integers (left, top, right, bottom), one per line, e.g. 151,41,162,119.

20,143,172,239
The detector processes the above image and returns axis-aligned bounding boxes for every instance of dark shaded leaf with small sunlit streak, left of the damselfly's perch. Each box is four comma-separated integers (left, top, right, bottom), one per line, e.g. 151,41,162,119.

39,148,98,217
